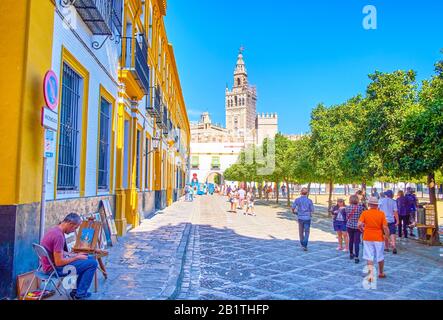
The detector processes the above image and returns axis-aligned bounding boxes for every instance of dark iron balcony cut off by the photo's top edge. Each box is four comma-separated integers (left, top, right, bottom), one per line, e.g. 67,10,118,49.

72,0,114,36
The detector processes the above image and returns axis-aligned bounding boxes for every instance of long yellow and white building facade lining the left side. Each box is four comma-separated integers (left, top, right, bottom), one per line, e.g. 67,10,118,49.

0,0,190,298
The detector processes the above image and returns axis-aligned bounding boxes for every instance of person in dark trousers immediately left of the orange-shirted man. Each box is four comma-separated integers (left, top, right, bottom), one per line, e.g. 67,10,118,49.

346,195,366,263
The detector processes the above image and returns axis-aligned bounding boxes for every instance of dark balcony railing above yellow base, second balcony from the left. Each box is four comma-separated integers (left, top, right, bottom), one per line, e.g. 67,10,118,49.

122,35,149,95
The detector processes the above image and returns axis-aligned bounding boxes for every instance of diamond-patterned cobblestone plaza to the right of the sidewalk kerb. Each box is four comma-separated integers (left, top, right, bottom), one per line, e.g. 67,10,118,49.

178,197,443,300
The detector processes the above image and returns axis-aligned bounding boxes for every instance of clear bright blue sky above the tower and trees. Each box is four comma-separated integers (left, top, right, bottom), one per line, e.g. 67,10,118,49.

166,0,443,133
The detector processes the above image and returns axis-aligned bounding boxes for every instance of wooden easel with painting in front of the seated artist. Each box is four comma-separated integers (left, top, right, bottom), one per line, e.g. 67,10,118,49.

72,218,109,292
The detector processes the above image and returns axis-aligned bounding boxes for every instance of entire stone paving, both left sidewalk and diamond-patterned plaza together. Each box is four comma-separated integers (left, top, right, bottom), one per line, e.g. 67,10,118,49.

92,196,443,300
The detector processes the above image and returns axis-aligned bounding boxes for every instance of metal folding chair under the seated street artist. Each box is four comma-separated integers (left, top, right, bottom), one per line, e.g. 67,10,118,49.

24,243,72,300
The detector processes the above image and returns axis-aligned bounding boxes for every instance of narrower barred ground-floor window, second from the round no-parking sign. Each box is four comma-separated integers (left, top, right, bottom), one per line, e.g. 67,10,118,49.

98,97,112,191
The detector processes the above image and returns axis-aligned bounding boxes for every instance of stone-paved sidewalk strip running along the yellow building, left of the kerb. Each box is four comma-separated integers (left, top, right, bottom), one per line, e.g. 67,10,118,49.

92,202,198,300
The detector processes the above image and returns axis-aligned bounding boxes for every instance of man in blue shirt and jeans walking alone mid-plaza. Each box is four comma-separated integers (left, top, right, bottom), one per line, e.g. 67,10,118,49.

292,188,314,251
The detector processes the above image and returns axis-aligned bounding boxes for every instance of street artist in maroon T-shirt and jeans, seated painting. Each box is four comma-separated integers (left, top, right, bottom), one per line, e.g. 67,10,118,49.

41,213,97,300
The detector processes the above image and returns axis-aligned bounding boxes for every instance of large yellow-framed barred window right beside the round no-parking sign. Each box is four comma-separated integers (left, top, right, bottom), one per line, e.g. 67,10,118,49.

57,63,83,191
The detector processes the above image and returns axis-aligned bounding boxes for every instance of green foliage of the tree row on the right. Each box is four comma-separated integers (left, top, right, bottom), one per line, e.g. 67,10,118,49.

225,51,443,190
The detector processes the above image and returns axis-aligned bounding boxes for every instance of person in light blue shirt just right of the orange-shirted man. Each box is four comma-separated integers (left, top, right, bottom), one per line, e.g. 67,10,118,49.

378,190,399,254
